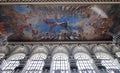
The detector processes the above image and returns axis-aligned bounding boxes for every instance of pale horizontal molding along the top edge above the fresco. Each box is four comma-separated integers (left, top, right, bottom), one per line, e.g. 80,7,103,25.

0,1,120,5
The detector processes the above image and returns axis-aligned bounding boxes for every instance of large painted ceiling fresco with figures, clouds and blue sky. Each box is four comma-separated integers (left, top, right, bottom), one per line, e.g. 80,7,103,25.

0,5,120,41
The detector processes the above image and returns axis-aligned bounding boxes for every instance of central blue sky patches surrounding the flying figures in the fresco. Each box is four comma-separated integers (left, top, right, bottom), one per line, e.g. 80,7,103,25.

36,15,78,33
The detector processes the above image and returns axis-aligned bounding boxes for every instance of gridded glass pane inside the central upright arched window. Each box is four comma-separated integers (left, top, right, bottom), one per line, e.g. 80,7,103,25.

51,55,69,73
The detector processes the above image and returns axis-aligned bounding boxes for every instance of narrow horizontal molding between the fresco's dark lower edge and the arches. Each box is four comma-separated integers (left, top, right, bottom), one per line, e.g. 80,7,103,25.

9,41,115,45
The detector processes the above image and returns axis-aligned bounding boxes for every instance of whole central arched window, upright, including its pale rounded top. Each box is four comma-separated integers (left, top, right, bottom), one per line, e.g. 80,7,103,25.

51,53,70,73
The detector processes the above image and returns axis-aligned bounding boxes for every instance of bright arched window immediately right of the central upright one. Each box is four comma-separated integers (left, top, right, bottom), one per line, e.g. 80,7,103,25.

74,53,96,73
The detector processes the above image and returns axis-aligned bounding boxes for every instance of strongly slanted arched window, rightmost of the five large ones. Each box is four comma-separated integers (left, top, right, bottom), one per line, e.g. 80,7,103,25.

95,52,120,73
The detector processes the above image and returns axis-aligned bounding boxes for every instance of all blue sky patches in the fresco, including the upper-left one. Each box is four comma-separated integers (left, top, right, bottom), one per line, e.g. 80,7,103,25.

15,5,82,33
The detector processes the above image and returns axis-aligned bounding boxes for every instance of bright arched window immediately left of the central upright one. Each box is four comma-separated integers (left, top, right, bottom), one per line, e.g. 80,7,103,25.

23,53,47,73
